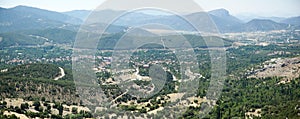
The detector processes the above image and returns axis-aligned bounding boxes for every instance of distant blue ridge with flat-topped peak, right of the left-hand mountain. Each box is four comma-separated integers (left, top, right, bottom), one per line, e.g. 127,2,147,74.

64,9,299,33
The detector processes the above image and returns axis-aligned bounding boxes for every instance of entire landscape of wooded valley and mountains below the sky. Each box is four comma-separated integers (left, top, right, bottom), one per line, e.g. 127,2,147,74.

0,3,300,119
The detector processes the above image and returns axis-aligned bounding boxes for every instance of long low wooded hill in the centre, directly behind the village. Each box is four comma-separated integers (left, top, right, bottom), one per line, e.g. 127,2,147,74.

98,33,233,50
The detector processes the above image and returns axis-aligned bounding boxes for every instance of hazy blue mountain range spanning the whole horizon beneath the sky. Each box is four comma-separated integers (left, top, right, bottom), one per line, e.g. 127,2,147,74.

0,6,300,33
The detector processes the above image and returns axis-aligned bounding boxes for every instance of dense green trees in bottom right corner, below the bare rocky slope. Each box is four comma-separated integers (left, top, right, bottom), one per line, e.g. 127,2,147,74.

183,77,300,118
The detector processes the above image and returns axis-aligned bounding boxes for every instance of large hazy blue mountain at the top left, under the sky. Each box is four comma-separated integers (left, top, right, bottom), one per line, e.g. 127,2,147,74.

0,6,81,32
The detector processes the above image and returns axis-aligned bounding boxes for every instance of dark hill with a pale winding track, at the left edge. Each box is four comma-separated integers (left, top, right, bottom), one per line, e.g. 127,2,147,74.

0,28,81,49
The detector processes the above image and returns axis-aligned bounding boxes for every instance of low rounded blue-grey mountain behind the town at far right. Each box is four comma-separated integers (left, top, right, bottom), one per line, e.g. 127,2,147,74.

236,19,288,32
